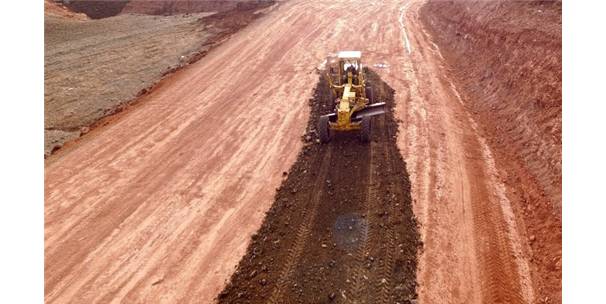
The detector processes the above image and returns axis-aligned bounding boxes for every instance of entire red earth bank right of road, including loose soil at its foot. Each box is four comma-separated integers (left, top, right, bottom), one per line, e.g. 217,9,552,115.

420,1,562,303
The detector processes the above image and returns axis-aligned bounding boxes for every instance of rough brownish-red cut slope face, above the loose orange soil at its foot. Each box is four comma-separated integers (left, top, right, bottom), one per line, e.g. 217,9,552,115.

422,1,562,210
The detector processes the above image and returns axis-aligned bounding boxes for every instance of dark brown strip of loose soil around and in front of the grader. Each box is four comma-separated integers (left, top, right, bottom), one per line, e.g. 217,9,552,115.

218,71,421,304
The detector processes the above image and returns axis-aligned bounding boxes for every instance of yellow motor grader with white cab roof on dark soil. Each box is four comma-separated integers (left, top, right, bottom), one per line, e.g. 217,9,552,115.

318,51,385,143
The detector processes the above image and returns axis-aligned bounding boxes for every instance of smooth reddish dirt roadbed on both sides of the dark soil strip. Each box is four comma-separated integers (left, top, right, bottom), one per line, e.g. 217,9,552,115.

45,1,534,303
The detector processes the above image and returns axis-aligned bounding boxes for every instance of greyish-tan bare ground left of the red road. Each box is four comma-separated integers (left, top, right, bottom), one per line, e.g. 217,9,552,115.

44,1,276,156
